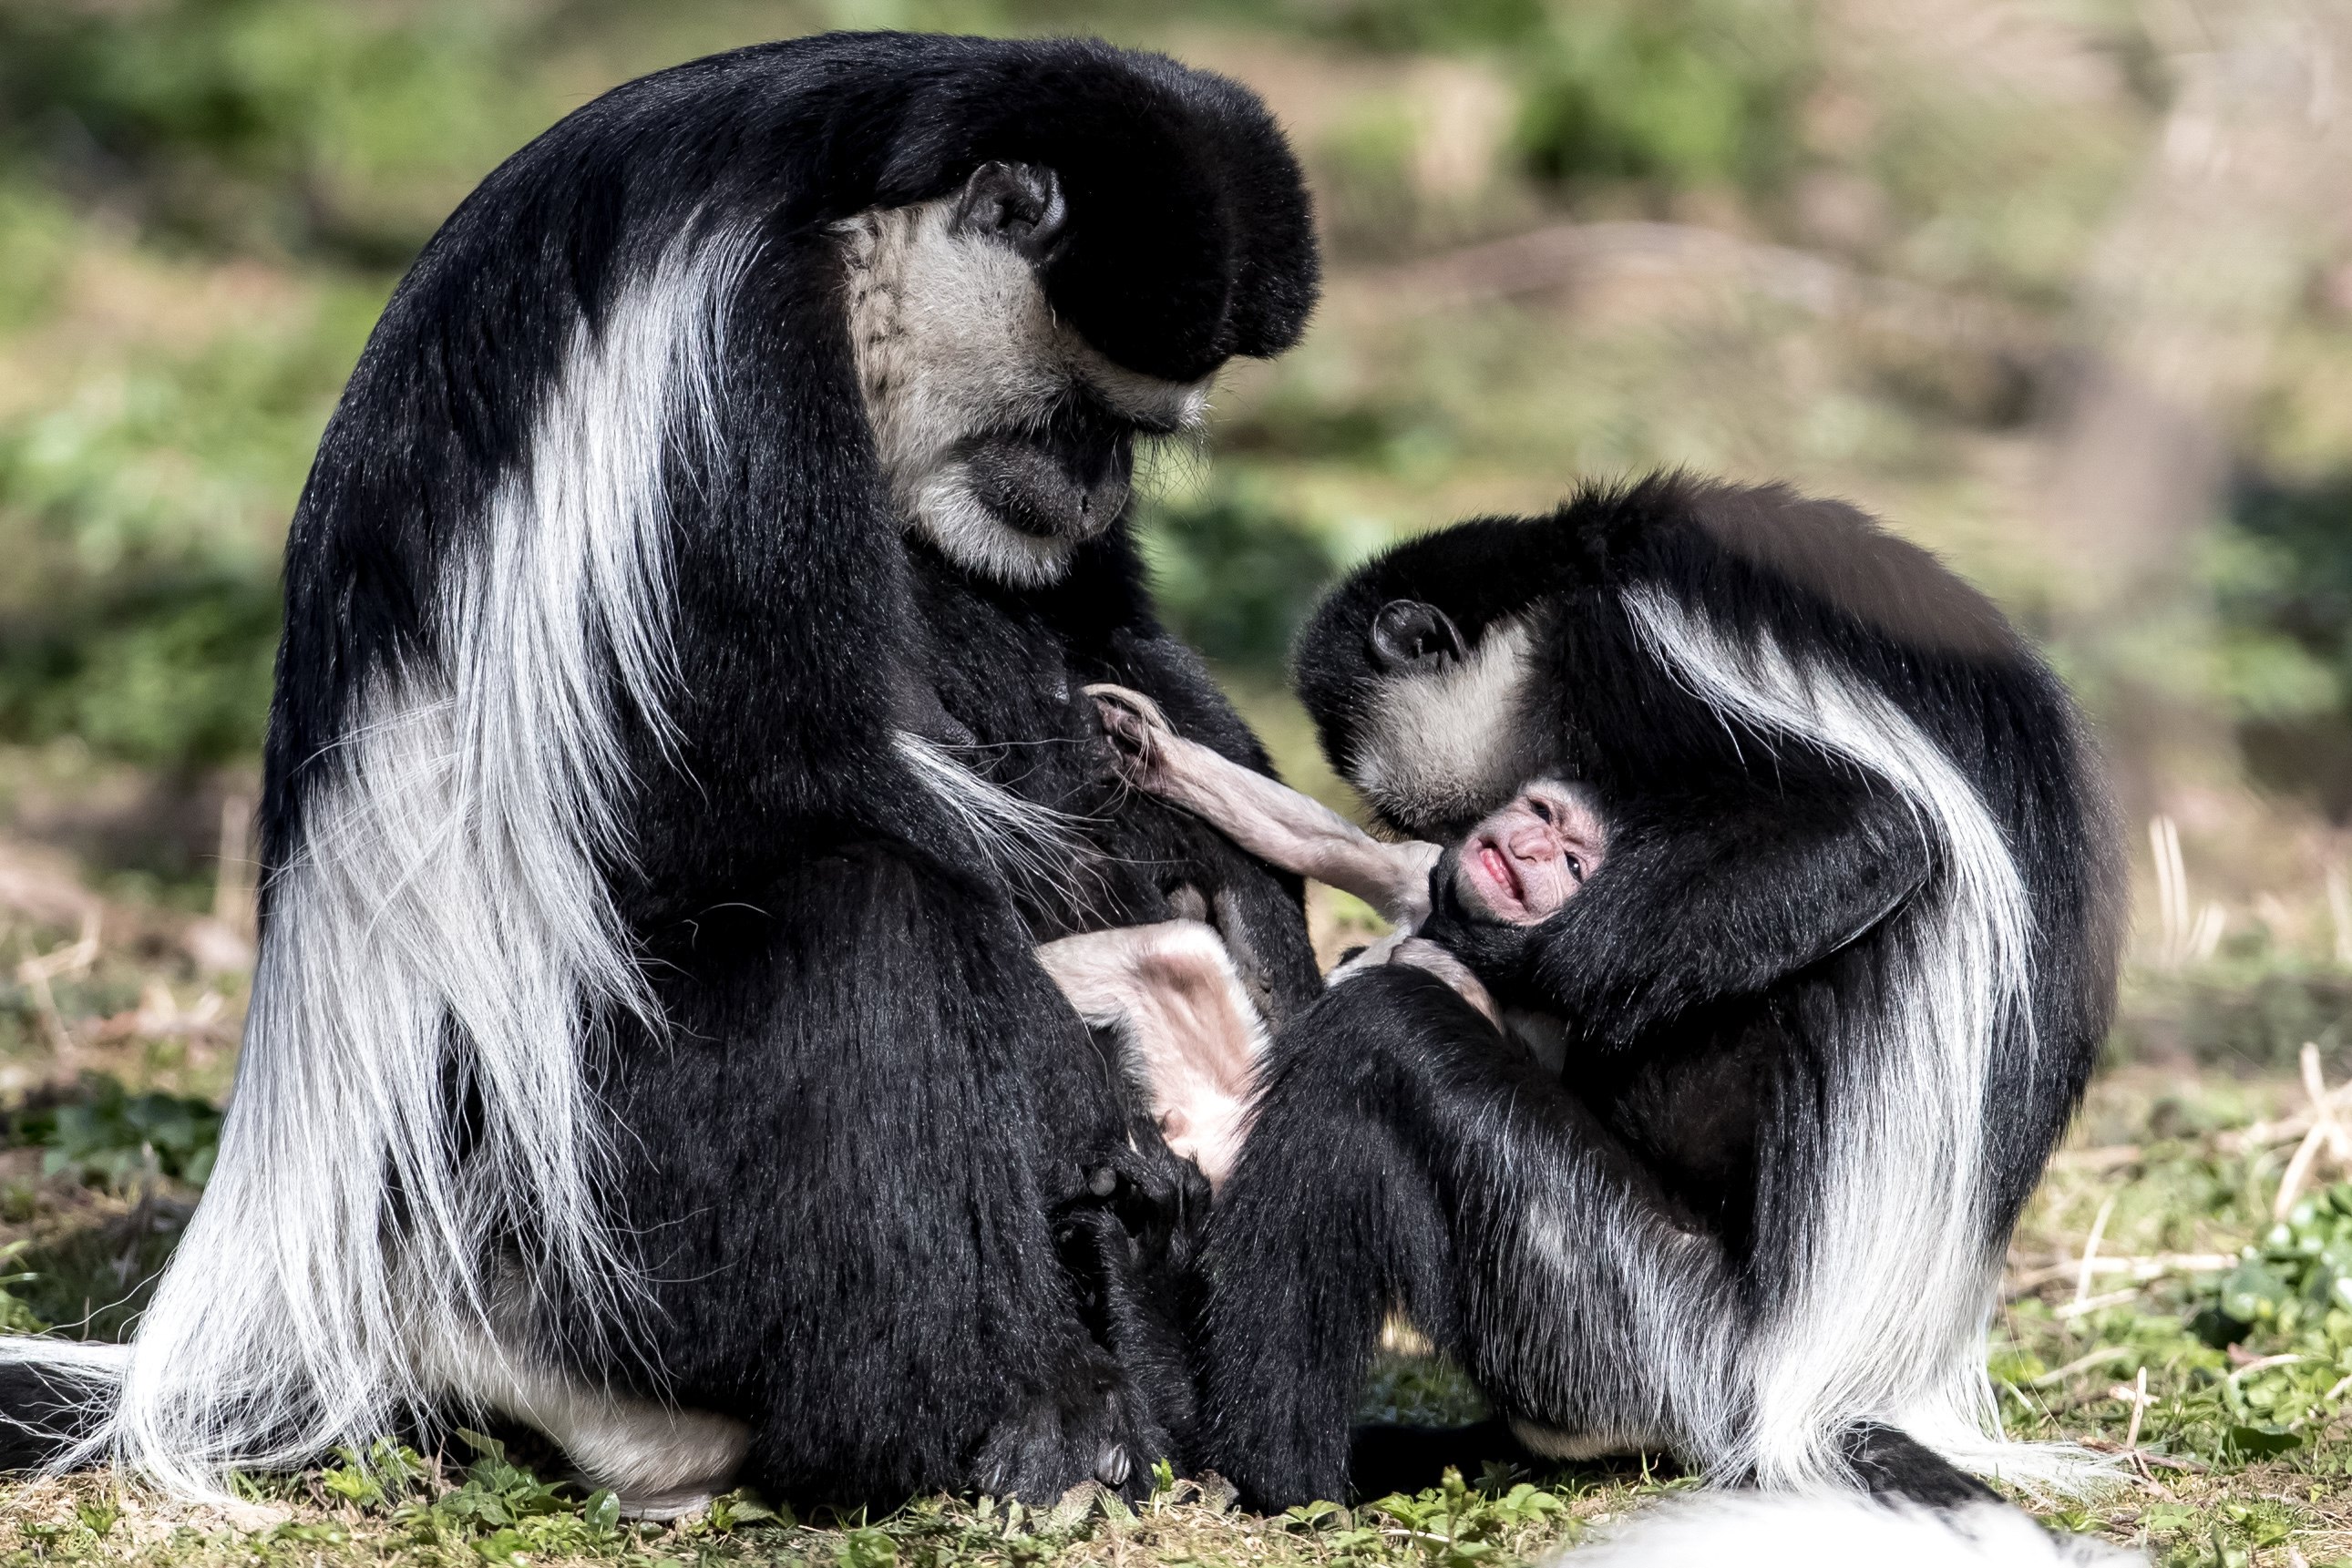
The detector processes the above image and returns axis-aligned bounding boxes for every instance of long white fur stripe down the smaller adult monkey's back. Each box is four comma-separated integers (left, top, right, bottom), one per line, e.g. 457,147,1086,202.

1625,588,2091,1488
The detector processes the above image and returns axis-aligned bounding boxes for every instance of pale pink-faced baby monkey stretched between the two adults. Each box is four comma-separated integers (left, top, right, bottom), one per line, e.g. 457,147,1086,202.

1037,684,1608,1192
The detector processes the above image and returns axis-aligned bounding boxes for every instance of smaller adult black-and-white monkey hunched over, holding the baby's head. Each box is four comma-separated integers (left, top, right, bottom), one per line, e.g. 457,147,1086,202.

1134,477,2119,1504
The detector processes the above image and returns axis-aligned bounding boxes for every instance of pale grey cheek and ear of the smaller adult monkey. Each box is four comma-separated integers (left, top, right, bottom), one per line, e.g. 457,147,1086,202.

1345,600,1546,839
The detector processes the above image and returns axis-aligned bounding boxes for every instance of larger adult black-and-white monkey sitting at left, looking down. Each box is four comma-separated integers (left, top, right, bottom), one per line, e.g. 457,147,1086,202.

9,36,1317,1507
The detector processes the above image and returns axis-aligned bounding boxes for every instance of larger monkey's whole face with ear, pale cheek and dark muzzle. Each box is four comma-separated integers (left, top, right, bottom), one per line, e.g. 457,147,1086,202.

845,162,1209,588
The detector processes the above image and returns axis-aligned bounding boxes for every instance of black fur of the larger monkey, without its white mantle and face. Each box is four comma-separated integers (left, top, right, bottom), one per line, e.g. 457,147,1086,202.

0,36,1317,1507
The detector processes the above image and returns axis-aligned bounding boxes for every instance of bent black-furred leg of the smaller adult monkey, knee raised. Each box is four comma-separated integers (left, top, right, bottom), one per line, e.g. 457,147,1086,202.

1197,966,1748,1507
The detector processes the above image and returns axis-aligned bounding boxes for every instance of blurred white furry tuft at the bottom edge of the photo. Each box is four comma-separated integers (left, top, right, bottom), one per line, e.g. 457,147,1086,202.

1547,1492,2145,1568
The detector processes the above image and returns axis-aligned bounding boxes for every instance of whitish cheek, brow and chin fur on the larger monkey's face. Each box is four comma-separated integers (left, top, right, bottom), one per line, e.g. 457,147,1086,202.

842,198,1209,588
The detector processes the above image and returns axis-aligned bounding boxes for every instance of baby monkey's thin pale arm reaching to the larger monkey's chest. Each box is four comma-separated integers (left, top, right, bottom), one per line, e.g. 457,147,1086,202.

1086,686,1440,927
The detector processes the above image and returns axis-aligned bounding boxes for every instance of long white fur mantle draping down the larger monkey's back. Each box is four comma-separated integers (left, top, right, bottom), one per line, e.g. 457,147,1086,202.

0,235,753,1498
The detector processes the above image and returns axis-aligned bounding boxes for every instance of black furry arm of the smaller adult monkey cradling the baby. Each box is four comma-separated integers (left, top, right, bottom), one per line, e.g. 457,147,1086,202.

1423,762,1936,1046
